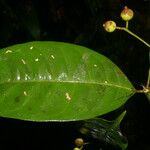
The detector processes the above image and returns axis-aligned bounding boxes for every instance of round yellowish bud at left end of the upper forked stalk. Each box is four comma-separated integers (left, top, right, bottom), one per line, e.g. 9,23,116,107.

103,21,116,32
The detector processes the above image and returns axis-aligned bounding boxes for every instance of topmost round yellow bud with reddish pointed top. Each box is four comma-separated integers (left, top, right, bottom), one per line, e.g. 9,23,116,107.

120,6,134,21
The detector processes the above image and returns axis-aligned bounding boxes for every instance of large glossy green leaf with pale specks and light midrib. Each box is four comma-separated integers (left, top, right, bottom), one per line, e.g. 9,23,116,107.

0,42,135,121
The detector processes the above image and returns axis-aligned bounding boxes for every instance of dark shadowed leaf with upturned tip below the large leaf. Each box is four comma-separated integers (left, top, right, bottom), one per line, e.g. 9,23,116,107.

80,111,128,150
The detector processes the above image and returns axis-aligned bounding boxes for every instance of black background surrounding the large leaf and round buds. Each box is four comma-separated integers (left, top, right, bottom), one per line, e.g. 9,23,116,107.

0,0,150,150
